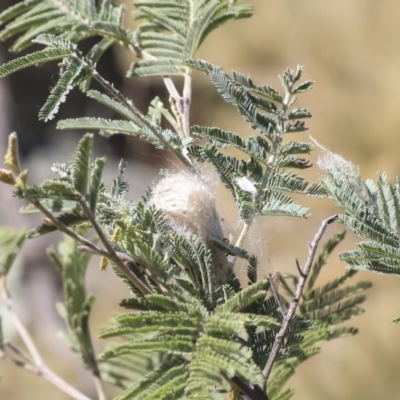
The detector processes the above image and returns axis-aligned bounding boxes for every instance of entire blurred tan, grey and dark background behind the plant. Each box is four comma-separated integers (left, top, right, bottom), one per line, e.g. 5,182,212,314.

0,0,400,400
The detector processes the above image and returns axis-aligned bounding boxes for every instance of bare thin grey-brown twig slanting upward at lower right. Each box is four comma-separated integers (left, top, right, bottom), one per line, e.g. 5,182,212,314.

263,215,337,382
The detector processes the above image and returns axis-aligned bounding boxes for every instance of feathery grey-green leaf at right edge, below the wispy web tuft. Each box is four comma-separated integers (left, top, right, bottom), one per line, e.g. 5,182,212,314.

322,173,400,276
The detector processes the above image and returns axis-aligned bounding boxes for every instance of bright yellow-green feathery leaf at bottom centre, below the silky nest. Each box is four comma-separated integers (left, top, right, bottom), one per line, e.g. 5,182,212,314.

102,282,278,399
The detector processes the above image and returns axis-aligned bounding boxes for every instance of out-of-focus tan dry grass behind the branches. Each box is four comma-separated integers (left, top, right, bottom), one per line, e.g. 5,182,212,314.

0,0,400,400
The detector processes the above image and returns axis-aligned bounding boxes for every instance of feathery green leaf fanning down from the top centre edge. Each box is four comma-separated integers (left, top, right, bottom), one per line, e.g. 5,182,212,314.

128,0,252,76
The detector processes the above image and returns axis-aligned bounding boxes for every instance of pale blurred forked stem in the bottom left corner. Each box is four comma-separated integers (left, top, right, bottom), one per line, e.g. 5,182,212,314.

0,277,91,400
